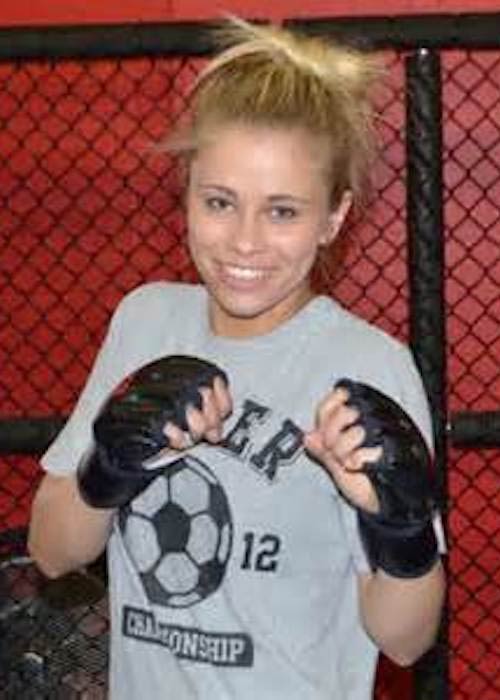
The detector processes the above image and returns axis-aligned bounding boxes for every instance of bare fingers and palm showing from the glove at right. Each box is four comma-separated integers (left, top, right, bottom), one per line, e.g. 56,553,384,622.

304,388,382,513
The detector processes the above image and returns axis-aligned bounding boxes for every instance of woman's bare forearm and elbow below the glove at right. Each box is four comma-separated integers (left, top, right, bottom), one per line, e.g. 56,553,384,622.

359,563,445,666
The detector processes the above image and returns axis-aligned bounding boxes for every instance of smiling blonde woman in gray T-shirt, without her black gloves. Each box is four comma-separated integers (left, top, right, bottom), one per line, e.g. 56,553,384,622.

30,21,444,700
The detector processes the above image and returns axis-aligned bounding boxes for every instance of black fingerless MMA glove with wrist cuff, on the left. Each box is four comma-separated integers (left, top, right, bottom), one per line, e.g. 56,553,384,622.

77,355,227,508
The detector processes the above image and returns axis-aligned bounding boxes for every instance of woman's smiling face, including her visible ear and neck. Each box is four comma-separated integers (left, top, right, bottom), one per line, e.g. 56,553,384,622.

187,125,350,337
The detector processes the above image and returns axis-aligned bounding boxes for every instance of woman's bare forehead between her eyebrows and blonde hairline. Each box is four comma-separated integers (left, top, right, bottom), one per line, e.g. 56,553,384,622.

190,124,329,188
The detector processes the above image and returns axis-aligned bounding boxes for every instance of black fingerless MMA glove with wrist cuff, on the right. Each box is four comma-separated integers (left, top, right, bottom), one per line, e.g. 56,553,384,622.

335,379,438,578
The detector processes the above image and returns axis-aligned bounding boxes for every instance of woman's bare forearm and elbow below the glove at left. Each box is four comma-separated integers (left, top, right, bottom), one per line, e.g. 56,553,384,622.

28,474,114,578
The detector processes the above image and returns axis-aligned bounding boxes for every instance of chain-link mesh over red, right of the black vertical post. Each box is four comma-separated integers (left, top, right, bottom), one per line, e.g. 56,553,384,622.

443,51,500,700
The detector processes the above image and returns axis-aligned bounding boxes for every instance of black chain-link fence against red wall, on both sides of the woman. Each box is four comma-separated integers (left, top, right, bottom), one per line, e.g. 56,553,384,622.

0,19,500,700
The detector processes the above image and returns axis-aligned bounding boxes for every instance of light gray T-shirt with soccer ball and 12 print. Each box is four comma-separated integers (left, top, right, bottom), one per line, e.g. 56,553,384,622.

42,282,431,700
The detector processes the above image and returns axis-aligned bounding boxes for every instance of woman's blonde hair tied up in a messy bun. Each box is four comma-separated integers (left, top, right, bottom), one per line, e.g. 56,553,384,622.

164,17,383,208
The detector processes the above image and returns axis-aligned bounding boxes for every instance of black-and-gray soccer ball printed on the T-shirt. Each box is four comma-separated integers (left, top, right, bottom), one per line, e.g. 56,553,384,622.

118,457,233,608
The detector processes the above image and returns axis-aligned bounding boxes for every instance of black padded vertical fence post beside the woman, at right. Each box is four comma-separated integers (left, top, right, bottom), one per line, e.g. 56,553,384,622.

406,49,449,700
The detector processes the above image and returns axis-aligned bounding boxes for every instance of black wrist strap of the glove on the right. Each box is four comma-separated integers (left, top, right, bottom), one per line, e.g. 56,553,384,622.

358,510,439,578
